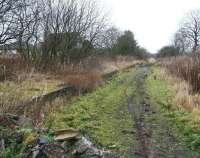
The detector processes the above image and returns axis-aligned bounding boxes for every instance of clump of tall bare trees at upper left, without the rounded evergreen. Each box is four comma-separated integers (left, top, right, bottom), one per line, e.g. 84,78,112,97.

0,0,107,62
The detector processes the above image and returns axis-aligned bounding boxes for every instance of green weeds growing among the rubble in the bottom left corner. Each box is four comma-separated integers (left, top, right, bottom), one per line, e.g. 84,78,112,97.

0,125,54,158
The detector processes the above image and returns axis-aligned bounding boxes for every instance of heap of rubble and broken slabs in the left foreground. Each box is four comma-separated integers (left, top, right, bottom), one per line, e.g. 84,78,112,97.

0,115,120,158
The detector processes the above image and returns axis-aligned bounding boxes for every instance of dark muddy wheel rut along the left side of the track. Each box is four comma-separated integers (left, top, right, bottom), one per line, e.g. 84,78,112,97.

127,67,159,158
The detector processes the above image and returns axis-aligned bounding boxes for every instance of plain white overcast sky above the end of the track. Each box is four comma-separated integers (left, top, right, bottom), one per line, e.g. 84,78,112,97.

102,0,200,53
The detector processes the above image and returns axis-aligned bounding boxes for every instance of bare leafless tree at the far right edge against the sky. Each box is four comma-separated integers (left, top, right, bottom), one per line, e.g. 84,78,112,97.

179,10,200,52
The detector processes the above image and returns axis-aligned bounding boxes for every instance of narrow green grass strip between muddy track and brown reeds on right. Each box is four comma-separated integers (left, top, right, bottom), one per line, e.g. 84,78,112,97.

146,67,200,153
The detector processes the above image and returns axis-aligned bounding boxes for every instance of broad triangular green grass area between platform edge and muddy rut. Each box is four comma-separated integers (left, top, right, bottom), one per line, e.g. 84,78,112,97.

46,70,139,156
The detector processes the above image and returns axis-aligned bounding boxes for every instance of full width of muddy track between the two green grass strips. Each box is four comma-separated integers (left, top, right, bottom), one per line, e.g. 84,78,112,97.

127,66,199,158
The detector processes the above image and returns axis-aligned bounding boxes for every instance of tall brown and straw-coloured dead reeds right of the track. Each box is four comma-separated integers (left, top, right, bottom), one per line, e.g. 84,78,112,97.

160,56,200,114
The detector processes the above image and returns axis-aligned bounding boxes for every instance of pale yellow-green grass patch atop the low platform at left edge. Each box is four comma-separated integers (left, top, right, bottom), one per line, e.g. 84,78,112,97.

0,76,61,113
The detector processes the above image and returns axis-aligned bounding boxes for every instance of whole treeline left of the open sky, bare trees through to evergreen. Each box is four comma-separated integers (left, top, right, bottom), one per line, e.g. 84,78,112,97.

0,0,148,63
